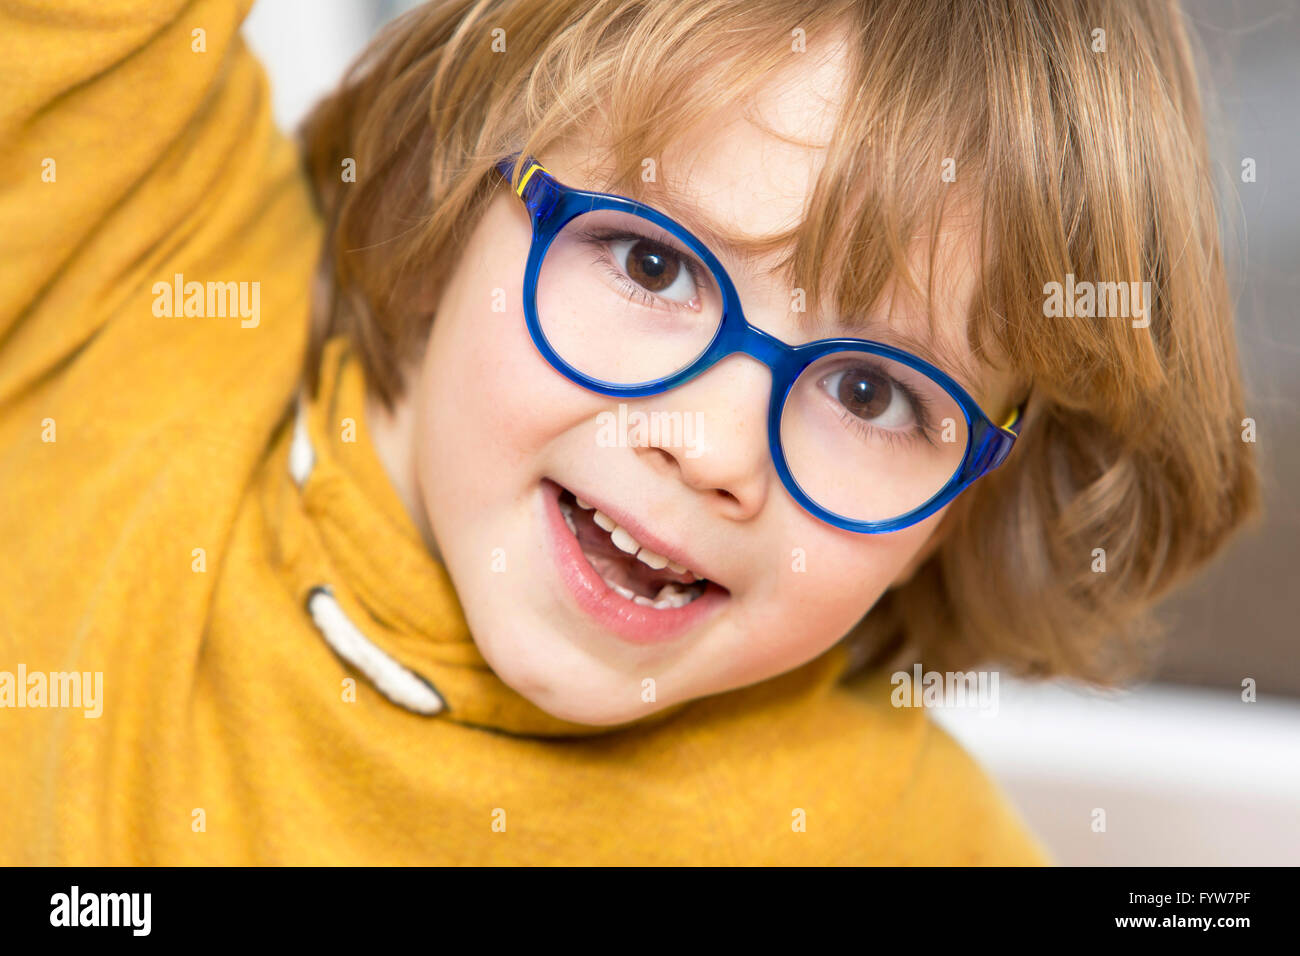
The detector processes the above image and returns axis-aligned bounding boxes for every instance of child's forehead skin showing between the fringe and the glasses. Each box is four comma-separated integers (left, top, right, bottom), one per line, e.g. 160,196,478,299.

543,43,1014,414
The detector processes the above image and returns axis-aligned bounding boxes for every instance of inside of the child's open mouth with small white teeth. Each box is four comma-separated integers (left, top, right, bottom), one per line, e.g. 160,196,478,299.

556,488,718,610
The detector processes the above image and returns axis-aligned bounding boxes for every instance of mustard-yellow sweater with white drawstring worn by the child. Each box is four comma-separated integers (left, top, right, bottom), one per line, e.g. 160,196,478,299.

0,0,1047,865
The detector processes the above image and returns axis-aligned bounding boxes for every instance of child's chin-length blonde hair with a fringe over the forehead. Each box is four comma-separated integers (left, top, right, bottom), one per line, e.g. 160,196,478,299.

302,0,1257,683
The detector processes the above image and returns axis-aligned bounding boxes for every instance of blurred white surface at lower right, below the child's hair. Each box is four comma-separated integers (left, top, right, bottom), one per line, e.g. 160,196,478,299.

932,680,1300,866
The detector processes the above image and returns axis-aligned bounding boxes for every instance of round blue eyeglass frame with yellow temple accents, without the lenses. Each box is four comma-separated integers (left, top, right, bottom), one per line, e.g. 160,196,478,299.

497,153,1027,535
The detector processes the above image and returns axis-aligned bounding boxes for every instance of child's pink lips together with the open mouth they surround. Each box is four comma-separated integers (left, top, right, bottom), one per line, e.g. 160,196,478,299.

542,480,729,644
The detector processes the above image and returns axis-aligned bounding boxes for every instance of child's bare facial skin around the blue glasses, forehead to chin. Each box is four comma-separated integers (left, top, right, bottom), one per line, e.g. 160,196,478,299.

381,48,1011,724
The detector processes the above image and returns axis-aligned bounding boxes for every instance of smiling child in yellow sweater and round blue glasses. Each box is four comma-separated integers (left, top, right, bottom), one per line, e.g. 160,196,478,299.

0,0,1255,864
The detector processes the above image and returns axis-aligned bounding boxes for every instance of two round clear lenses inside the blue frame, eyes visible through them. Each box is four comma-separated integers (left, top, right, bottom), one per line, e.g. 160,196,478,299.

537,209,967,522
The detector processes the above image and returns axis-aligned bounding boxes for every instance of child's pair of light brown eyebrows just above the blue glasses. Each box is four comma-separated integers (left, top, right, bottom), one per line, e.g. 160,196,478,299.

595,175,987,405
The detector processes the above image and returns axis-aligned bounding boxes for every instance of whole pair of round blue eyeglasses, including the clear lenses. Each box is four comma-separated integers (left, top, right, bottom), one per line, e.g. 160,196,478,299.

497,155,1023,535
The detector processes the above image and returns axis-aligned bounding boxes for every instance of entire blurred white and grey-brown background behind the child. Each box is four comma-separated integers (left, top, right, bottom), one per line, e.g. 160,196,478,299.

244,0,1300,865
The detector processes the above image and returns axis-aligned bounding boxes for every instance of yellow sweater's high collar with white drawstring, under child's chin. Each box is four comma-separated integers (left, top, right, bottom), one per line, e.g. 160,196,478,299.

272,339,759,736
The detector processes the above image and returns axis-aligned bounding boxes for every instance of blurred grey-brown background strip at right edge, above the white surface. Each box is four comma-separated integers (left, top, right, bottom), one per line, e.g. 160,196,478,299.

1161,0,1300,696
